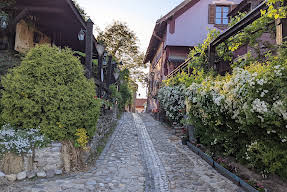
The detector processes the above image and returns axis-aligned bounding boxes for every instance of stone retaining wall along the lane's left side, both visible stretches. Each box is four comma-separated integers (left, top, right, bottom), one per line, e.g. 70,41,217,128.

0,111,117,185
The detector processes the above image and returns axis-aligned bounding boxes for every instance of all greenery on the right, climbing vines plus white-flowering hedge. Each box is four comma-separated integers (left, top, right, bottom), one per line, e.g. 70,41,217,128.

162,0,287,178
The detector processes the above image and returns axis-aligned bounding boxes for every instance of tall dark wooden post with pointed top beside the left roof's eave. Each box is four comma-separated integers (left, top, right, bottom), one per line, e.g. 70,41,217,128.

85,19,94,79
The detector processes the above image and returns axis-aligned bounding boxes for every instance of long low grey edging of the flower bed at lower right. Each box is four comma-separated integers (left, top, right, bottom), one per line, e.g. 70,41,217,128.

187,142,258,192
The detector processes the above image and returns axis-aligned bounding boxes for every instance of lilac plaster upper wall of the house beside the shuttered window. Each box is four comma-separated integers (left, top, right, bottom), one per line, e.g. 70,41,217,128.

166,0,242,46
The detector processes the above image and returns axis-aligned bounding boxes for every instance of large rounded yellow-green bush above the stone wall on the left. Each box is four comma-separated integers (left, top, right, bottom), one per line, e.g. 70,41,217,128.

1,45,100,140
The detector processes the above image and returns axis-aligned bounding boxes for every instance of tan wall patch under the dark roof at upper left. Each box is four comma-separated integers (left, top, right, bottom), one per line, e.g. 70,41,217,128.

15,20,51,53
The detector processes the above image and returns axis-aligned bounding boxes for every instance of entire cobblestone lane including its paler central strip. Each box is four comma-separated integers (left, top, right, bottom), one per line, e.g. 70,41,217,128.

0,113,245,192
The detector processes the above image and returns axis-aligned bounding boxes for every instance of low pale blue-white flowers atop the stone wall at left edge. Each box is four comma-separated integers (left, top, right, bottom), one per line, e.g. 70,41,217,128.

0,124,49,154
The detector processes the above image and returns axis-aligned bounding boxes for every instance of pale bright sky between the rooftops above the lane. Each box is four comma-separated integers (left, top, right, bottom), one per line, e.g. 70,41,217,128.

77,0,183,98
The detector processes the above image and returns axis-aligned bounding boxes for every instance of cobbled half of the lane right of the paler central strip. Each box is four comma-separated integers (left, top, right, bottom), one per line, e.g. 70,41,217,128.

140,114,243,192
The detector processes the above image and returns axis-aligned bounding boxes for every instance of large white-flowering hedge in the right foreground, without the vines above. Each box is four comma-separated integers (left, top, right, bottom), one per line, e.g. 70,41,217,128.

187,46,287,177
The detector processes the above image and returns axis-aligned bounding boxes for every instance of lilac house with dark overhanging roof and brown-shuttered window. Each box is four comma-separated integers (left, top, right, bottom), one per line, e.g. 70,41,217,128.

144,0,242,111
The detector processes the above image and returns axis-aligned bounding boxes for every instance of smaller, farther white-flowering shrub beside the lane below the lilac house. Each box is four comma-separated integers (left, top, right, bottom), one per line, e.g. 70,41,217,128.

158,85,185,122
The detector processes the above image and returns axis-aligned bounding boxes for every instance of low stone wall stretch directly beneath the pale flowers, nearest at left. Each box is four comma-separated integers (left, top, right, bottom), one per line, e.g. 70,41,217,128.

0,143,63,181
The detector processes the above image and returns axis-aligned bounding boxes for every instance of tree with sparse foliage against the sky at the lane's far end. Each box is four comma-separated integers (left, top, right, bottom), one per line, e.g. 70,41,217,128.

97,21,146,82
